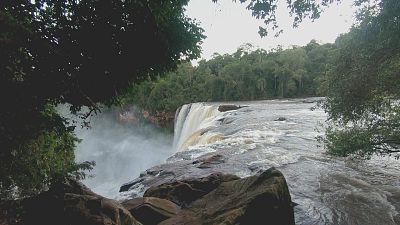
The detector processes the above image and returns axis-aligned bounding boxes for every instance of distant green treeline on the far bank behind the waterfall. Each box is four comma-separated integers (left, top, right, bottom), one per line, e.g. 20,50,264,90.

122,40,336,112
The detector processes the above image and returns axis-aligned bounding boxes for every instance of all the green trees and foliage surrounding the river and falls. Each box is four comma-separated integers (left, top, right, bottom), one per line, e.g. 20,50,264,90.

0,0,400,199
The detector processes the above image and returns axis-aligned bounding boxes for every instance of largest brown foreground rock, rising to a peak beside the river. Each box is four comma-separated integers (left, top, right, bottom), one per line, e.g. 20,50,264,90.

160,168,294,225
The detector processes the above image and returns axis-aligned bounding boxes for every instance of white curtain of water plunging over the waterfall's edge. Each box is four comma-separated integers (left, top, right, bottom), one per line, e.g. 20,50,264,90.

174,103,221,151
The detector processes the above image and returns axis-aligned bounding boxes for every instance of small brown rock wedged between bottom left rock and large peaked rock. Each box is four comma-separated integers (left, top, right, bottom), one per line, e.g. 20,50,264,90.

121,197,180,225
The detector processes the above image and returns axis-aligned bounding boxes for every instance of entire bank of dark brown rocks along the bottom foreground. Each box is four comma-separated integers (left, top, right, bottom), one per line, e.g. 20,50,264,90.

0,168,294,225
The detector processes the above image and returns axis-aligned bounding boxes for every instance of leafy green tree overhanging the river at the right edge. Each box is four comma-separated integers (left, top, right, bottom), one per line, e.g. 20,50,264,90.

324,0,400,157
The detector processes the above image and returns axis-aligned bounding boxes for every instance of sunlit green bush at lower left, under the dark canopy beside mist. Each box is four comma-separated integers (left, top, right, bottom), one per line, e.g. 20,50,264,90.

0,129,94,199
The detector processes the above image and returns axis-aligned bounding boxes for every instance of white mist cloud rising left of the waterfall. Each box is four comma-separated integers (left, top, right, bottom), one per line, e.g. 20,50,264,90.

75,106,174,198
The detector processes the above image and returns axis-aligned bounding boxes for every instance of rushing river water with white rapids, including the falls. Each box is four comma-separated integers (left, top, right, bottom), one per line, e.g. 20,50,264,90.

76,99,400,225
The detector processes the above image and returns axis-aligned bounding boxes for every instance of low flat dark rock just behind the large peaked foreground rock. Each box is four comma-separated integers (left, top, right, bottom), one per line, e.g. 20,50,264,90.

144,173,239,207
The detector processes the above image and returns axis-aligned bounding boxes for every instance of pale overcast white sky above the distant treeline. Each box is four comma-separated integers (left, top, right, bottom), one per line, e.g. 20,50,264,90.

186,0,355,59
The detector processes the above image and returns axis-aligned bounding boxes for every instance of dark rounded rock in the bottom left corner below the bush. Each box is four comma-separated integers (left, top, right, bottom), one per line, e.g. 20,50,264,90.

0,179,140,225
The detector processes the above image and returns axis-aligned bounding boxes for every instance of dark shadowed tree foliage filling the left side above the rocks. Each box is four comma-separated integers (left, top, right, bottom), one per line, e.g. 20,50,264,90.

0,0,204,197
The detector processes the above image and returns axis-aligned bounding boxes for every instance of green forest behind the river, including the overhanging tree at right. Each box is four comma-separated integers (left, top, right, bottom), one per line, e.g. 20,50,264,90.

122,0,400,161
